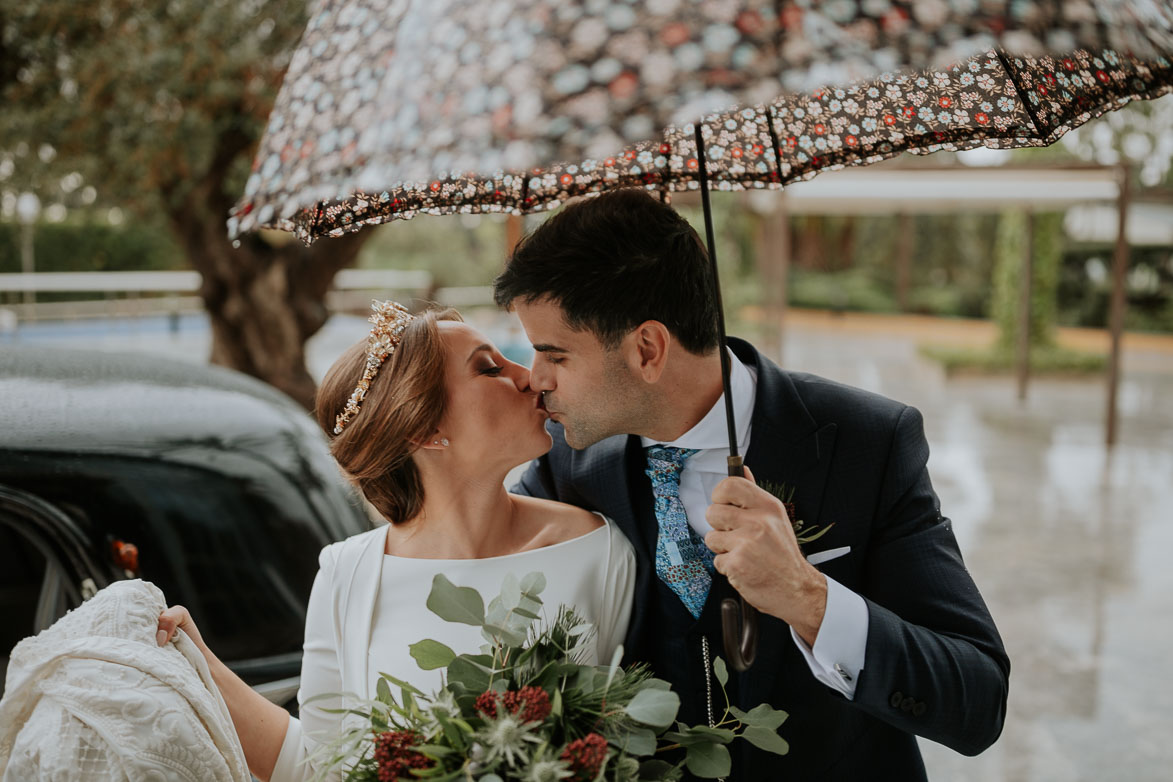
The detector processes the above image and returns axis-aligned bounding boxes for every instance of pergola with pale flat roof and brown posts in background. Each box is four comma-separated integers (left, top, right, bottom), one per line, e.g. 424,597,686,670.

674,159,1160,446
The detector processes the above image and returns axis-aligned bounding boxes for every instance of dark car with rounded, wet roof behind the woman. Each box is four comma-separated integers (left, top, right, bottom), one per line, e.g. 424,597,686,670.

0,347,371,708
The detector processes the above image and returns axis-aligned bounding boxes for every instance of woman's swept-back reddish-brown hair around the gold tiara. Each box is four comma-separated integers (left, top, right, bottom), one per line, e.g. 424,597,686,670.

314,310,462,524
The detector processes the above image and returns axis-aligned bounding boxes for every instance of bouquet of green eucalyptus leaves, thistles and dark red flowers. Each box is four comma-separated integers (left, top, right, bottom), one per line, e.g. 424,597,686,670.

307,573,787,782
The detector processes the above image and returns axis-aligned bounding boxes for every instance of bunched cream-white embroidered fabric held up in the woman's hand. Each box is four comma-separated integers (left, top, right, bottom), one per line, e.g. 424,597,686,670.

0,580,251,782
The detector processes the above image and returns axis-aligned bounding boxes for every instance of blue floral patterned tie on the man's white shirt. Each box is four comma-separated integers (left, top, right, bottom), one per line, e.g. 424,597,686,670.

646,446,713,618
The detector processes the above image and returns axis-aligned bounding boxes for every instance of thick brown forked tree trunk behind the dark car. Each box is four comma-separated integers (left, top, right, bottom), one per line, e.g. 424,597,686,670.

170,193,369,409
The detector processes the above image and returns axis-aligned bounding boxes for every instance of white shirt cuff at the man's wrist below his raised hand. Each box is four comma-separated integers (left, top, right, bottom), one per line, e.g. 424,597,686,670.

791,576,868,700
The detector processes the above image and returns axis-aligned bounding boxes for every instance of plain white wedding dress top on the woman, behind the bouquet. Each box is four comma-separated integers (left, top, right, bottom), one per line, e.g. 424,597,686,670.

272,521,636,782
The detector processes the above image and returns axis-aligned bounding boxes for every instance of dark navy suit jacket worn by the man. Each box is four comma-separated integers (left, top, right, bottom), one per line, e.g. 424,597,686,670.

515,339,1010,782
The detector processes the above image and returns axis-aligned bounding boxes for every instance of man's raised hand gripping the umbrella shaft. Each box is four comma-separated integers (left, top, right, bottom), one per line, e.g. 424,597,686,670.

705,469,827,646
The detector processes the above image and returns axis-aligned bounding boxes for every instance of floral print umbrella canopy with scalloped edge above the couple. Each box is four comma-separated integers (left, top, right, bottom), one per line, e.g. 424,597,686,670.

229,0,1173,242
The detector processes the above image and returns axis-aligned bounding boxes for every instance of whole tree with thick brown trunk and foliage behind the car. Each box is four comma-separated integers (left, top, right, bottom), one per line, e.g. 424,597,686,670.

0,0,367,406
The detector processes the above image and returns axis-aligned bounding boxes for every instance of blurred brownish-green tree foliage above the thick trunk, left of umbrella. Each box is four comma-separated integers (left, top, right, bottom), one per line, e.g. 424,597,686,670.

0,0,307,213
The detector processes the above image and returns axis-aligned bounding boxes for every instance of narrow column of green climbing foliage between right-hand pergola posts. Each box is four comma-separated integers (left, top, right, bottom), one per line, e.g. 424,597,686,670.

990,212,1063,349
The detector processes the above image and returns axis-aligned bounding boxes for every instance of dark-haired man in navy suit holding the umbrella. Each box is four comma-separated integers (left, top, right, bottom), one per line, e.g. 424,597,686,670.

495,190,1010,782
